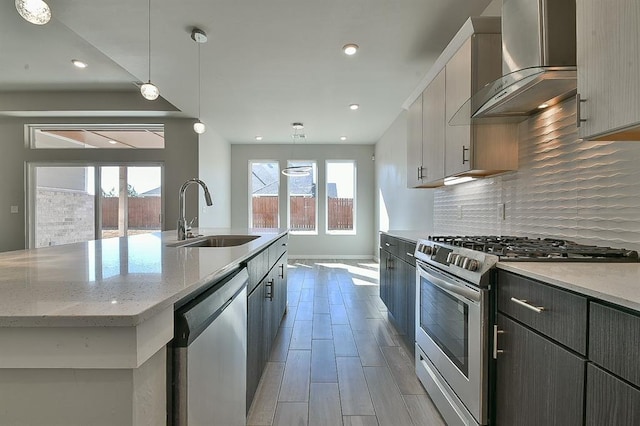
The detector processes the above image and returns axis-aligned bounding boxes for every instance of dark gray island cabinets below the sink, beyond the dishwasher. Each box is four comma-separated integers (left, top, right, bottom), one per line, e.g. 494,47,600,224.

247,236,288,411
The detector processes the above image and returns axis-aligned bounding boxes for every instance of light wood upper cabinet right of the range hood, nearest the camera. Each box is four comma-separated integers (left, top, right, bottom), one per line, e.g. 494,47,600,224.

576,0,640,141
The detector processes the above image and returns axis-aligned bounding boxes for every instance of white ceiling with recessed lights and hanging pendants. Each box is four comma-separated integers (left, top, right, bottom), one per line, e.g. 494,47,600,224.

0,0,490,144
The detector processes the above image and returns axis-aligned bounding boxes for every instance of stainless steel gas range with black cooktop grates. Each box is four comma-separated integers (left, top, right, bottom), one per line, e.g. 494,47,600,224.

414,236,638,426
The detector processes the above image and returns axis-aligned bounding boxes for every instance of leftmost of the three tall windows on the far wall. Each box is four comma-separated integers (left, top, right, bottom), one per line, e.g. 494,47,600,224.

249,161,280,228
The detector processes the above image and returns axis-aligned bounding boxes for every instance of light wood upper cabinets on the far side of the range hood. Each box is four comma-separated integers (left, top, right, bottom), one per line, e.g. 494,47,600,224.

407,17,518,188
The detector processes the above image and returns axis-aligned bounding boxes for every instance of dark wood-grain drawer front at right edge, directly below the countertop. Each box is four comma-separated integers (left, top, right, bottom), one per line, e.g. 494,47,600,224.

589,302,640,386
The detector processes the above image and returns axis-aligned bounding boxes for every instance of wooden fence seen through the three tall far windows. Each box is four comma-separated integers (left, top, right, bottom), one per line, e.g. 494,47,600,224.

252,196,353,231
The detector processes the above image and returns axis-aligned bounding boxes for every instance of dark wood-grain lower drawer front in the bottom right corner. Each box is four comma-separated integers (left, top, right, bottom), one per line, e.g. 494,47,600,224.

586,363,640,426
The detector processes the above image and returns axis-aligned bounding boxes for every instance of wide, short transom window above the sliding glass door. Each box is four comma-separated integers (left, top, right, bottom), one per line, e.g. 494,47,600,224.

28,124,164,149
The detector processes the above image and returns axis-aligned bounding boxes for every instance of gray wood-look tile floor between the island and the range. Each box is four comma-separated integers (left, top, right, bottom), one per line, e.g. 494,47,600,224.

248,260,445,426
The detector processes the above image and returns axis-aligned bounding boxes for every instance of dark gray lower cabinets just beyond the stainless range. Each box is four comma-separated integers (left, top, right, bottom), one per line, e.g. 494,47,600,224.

380,234,416,348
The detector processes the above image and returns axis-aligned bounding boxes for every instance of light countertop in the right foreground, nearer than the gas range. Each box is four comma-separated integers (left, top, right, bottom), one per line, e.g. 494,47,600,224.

498,262,640,312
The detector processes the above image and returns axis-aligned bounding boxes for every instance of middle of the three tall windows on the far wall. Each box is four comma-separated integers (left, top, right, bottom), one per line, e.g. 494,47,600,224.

287,161,318,234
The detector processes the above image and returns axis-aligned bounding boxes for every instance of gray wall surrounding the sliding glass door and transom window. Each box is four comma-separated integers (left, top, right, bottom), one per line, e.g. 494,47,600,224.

0,117,198,251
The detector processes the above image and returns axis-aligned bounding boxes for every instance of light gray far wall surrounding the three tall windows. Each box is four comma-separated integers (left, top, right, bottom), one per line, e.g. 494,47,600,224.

231,144,377,259
